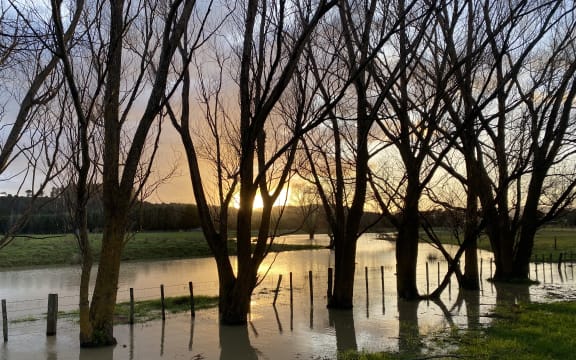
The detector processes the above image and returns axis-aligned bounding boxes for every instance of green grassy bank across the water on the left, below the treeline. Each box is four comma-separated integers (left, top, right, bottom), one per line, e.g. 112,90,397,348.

0,231,318,268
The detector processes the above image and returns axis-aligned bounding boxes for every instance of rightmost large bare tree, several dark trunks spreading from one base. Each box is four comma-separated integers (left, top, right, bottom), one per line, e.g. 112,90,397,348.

440,1,574,280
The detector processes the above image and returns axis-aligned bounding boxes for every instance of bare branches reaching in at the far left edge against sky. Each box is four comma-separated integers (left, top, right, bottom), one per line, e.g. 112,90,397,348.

0,1,70,248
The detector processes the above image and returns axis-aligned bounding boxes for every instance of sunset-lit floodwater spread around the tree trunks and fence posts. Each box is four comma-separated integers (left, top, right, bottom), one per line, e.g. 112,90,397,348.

0,234,575,360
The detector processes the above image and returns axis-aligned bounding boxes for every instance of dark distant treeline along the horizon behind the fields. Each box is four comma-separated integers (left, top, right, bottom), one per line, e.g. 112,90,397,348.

0,196,576,234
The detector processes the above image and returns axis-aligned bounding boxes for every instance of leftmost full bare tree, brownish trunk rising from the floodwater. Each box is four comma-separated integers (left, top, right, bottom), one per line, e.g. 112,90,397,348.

51,0,195,346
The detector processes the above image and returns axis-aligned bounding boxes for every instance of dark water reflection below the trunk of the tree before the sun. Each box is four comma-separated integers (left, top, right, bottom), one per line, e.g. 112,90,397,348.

219,325,258,360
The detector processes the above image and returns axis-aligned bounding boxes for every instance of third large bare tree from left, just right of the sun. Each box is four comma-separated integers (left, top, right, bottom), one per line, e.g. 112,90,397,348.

305,1,430,308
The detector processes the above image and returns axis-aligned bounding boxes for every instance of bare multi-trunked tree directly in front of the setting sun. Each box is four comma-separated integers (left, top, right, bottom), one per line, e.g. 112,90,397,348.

172,0,336,324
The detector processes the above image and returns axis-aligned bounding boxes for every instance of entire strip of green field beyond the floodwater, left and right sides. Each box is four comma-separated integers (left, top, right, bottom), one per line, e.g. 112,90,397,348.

0,228,576,268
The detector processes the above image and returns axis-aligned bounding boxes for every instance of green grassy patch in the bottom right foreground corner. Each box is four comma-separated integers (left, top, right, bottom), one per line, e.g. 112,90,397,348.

338,302,576,360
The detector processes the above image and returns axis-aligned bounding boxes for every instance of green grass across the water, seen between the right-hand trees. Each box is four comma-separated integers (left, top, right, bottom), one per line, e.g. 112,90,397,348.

422,227,576,261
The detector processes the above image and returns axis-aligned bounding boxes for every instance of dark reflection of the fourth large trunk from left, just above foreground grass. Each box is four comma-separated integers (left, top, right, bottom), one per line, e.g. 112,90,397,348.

398,298,422,354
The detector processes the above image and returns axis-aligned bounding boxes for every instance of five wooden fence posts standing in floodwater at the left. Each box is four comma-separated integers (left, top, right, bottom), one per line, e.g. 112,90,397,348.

2,277,197,342
